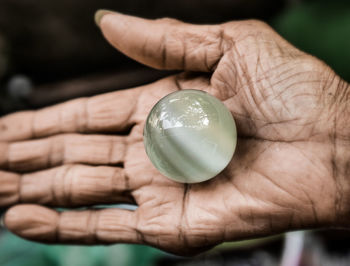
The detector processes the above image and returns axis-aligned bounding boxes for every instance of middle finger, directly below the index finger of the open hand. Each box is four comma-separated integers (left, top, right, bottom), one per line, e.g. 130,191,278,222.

0,134,127,172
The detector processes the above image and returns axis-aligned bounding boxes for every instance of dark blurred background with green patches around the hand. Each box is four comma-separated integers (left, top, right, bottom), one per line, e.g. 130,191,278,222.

0,0,350,266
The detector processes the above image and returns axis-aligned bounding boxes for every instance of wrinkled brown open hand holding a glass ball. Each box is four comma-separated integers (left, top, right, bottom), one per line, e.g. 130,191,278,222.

0,13,350,255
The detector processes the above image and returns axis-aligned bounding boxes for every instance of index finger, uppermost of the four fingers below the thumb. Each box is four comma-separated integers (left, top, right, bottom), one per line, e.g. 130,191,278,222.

0,87,143,141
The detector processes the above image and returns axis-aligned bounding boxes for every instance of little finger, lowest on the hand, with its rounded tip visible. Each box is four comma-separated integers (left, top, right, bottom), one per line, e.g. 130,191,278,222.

4,205,142,244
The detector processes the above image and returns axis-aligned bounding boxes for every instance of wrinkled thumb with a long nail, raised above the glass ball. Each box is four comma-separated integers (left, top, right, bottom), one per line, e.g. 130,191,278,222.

96,11,224,72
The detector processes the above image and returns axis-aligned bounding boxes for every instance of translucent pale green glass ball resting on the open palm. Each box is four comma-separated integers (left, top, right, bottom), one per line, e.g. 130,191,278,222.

143,90,237,183
